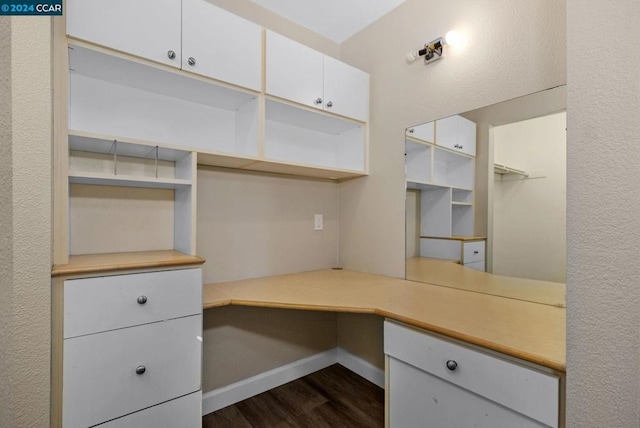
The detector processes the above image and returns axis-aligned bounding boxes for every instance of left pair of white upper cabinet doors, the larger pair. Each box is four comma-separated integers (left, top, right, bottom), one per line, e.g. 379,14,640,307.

67,0,262,91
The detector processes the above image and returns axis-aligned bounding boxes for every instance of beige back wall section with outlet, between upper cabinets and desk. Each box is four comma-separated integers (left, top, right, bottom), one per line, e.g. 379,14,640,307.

196,166,338,284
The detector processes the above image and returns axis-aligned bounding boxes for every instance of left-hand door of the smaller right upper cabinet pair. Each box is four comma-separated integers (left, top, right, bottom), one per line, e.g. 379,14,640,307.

266,31,324,108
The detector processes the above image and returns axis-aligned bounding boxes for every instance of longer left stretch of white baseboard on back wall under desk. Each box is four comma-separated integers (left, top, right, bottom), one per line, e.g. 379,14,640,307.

202,348,337,415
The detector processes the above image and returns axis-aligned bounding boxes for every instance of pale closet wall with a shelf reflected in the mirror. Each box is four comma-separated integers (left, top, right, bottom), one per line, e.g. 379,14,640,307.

491,112,567,282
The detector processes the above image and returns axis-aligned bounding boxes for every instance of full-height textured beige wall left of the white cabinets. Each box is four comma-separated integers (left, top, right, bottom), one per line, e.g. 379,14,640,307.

0,17,52,428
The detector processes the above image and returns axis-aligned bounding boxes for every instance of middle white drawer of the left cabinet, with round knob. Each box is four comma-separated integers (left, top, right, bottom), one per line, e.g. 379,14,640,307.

62,315,202,428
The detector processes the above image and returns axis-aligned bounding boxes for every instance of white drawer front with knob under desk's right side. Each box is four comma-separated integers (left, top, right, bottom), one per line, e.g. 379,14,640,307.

384,321,559,427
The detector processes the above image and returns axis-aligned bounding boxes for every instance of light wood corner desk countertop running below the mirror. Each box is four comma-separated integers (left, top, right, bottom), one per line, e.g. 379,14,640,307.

203,270,566,372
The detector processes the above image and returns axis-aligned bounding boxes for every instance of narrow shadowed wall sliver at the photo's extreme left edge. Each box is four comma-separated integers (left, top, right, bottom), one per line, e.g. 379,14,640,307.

0,16,13,427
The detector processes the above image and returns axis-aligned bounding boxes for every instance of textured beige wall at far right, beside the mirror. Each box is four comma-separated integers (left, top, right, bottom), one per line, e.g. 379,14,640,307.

567,0,640,428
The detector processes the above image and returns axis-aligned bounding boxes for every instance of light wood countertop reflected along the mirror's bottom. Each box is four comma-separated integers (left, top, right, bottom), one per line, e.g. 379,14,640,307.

406,257,567,307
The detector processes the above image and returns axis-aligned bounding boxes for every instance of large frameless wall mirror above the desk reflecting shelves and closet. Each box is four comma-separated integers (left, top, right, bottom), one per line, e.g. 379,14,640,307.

405,86,566,306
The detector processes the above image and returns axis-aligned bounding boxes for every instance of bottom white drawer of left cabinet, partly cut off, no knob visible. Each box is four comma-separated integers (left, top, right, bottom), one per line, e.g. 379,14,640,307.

100,391,202,428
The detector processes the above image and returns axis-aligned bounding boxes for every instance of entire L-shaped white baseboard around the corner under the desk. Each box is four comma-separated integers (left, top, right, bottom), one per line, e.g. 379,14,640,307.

202,348,384,415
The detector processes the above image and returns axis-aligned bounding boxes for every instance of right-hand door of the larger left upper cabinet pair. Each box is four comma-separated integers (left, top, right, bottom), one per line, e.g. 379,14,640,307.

182,0,262,91
